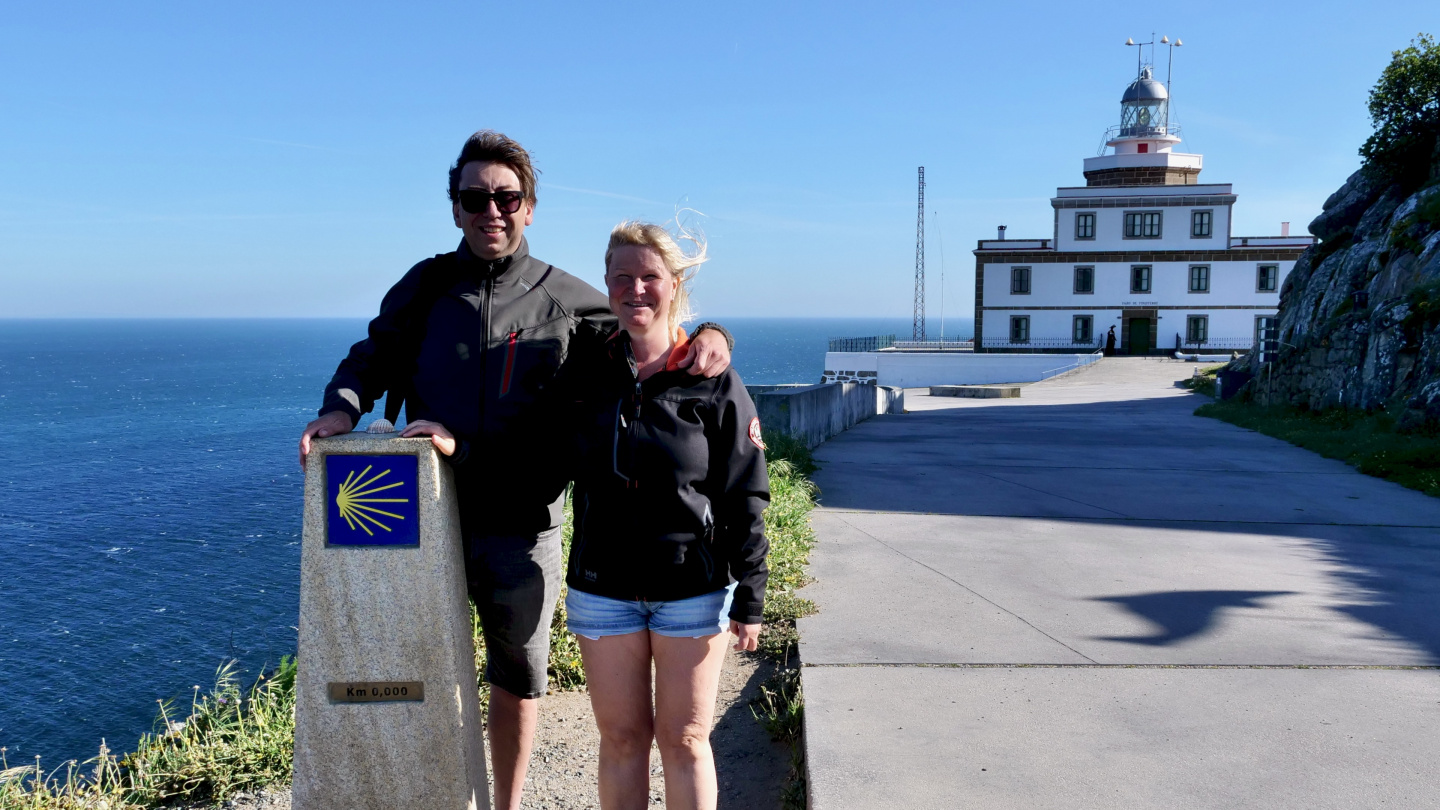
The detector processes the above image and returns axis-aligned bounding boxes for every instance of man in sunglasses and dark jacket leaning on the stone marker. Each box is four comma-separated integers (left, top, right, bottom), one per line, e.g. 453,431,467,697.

300,130,730,810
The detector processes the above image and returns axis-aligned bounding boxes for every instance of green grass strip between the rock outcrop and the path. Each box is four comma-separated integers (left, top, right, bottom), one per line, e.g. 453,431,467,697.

1195,399,1440,497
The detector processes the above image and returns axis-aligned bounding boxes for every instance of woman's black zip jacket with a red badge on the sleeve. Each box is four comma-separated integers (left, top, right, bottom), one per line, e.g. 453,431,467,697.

557,331,770,624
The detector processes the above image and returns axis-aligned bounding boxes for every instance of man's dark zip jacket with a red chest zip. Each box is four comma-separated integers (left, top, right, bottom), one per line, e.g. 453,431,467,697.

320,239,616,535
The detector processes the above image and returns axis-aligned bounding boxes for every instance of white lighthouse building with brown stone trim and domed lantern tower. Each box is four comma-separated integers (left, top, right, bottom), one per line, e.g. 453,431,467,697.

975,68,1315,355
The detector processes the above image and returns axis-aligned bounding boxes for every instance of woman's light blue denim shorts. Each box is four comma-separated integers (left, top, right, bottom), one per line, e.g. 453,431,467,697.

564,582,734,640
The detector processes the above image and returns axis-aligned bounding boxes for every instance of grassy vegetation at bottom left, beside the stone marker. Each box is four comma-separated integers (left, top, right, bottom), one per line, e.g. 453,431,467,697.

0,657,295,810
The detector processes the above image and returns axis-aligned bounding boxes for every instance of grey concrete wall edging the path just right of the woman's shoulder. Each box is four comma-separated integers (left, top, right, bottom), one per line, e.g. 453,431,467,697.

744,382,904,447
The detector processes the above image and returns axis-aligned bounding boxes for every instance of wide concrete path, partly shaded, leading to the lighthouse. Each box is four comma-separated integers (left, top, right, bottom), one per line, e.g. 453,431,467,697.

801,359,1440,810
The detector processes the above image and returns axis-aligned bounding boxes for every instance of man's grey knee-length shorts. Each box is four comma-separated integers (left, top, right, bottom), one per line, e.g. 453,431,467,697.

465,528,562,698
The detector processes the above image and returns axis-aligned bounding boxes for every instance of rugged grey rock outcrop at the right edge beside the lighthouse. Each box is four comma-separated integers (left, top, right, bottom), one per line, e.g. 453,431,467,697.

1234,149,1440,430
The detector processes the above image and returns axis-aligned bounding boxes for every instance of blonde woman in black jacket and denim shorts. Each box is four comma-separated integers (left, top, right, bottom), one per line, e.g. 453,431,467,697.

564,222,770,810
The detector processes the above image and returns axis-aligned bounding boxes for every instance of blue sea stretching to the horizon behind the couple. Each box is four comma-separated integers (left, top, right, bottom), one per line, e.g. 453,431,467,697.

0,319,969,767
